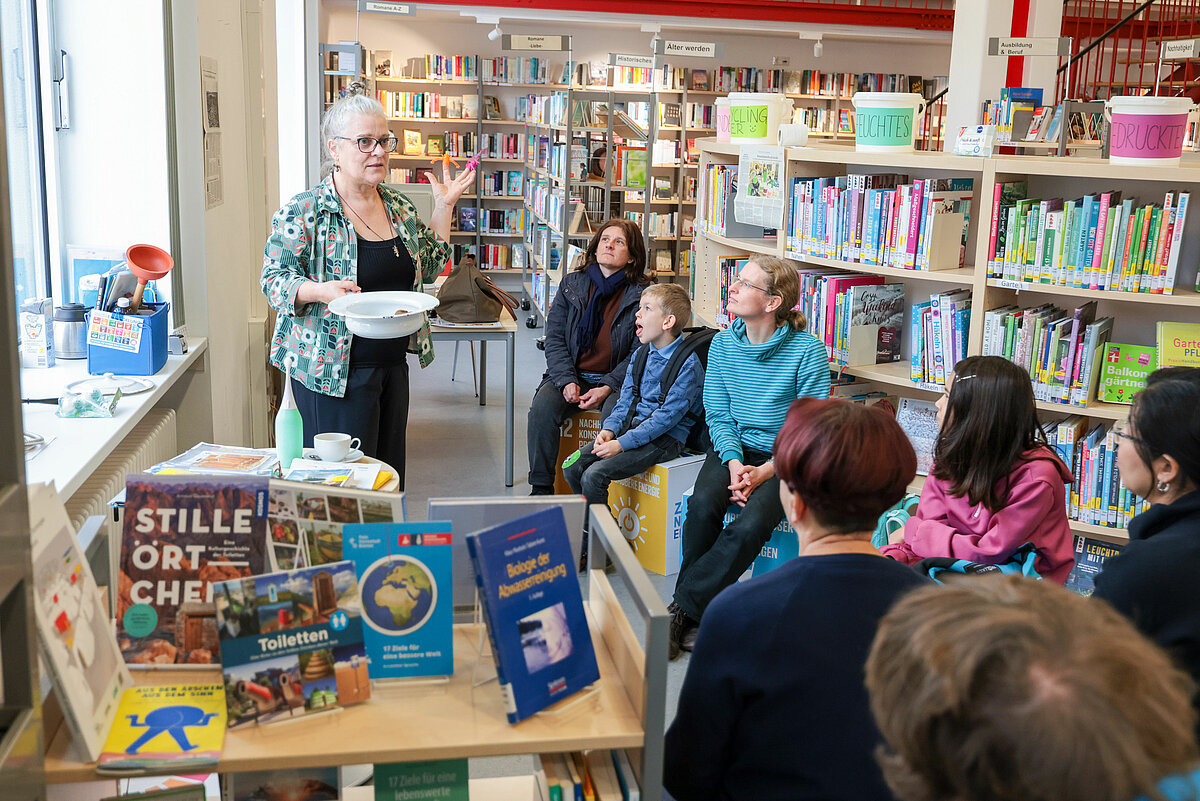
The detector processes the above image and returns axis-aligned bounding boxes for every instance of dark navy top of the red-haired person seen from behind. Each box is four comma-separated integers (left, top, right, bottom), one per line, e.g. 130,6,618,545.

662,554,929,801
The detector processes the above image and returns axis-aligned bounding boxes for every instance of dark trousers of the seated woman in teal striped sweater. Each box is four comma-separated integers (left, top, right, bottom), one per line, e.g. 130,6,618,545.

674,450,784,620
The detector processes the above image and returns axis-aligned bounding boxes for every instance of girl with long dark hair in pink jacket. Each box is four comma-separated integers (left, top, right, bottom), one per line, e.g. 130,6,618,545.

880,356,1075,584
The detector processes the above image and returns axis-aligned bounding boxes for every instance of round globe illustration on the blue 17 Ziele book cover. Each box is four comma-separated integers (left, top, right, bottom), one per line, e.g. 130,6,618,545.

361,556,438,637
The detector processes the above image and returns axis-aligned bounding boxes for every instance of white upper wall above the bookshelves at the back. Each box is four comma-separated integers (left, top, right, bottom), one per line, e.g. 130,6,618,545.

320,8,950,87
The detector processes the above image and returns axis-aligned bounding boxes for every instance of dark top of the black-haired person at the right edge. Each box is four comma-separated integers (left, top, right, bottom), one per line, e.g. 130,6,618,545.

1094,492,1200,739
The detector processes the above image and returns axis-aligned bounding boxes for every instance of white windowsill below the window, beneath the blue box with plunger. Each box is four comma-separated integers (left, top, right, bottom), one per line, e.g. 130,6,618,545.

20,337,209,500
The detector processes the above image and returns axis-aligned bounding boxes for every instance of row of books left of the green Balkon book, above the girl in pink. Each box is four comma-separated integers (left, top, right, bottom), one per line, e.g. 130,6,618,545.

983,301,1114,406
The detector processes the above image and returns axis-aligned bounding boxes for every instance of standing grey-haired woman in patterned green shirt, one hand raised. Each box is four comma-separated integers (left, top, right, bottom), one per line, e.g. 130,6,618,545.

262,87,474,489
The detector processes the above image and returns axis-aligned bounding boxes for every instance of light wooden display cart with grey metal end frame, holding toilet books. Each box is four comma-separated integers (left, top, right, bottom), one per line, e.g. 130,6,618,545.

46,506,667,801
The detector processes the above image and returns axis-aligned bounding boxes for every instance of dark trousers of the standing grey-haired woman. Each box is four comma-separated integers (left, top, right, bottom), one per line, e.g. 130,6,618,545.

284,362,408,490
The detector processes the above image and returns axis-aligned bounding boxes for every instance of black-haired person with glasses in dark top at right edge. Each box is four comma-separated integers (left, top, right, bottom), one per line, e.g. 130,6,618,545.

1094,367,1200,740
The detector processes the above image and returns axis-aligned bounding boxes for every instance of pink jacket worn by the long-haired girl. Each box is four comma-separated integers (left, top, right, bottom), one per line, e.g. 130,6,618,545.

880,447,1075,584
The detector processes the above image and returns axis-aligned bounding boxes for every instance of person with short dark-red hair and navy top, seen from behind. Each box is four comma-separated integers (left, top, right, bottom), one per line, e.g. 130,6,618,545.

664,398,928,801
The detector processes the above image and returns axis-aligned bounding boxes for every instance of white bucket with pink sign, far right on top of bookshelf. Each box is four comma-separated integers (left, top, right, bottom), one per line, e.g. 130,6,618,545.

1104,95,1192,167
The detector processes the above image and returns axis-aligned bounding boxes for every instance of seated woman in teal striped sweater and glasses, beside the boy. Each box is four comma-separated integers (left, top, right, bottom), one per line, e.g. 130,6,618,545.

670,255,829,658
